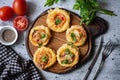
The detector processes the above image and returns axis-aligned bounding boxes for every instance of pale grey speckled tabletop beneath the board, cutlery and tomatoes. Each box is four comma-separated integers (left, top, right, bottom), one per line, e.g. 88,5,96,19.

0,0,120,80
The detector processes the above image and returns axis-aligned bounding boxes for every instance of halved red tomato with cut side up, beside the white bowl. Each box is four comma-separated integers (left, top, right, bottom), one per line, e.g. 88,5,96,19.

13,16,28,31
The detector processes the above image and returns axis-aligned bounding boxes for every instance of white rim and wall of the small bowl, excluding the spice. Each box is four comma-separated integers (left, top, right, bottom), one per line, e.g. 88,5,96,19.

0,26,18,46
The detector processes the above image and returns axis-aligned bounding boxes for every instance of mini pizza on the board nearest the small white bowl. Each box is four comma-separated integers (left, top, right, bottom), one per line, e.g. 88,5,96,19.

29,25,51,47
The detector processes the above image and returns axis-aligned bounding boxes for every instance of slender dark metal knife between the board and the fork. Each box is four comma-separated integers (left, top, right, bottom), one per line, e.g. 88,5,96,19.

83,36,103,80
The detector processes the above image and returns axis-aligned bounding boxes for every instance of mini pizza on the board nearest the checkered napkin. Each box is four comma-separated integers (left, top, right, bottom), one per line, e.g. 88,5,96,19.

33,47,56,69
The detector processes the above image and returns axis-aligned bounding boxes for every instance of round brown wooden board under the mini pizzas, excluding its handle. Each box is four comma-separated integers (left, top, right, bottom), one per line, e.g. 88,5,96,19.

26,10,92,73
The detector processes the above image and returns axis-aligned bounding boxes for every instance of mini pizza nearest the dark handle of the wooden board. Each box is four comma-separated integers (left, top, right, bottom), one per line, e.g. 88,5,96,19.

66,25,87,46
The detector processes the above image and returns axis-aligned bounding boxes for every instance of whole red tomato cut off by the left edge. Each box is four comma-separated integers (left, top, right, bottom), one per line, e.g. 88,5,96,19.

0,6,14,21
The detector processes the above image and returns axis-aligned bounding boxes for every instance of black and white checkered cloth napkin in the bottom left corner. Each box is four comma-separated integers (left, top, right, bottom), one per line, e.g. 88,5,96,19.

0,43,42,80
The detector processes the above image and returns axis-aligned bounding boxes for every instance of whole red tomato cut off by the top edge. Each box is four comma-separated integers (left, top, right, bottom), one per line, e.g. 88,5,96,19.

12,0,27,16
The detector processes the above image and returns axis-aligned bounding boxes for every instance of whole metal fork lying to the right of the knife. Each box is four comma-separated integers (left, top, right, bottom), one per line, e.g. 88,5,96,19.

93,41,113,80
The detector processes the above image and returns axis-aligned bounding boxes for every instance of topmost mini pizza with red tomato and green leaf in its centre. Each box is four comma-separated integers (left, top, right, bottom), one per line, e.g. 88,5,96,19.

46,8,70,32
